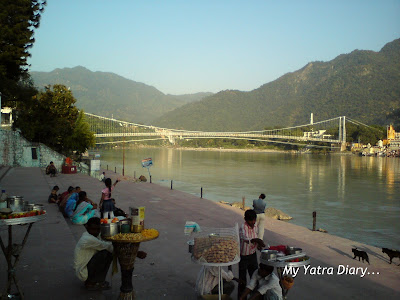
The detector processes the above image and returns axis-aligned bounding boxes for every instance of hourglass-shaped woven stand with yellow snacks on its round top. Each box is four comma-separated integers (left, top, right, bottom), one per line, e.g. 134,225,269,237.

103,229,159,300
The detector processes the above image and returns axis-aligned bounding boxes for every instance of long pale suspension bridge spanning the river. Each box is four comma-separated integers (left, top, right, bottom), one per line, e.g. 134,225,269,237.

85,113,376,149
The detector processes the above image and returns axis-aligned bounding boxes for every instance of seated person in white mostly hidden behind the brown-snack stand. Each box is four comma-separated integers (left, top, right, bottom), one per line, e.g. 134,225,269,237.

195,266,239,296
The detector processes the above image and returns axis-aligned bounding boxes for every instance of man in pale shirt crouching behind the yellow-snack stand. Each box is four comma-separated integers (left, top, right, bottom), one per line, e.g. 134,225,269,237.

74,217,147,290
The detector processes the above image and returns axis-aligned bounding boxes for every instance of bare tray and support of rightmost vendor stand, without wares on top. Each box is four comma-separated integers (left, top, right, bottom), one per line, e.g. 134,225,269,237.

260,252,310,299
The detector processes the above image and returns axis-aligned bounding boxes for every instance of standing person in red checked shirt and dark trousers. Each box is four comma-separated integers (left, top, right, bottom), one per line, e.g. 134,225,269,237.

238,209,265,296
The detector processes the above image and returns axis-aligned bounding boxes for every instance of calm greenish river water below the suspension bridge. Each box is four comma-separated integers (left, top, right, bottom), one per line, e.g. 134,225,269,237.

96,148,400,249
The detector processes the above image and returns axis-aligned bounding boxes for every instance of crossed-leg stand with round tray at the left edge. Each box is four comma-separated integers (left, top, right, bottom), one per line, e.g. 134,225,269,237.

0,212,46,300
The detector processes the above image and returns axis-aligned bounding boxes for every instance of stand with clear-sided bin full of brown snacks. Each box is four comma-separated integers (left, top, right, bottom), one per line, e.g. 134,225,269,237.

188,224,240,300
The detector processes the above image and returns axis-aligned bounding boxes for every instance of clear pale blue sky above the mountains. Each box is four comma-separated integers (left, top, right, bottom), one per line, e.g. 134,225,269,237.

29,0,400,94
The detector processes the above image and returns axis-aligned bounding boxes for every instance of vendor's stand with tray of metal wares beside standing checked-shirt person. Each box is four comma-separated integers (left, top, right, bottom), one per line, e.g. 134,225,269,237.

260,246,310,299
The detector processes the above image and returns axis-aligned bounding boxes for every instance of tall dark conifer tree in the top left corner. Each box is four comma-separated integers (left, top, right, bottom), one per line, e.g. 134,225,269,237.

0,0,46,100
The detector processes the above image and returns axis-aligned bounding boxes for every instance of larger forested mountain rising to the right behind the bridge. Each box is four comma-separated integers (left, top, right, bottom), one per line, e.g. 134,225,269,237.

154,39,400,131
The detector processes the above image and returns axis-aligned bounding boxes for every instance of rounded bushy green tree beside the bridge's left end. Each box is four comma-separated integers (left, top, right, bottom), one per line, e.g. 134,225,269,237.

14,84,94,155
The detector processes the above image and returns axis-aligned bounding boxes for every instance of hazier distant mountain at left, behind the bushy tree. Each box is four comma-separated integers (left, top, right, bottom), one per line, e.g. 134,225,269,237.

31,66,212,124
